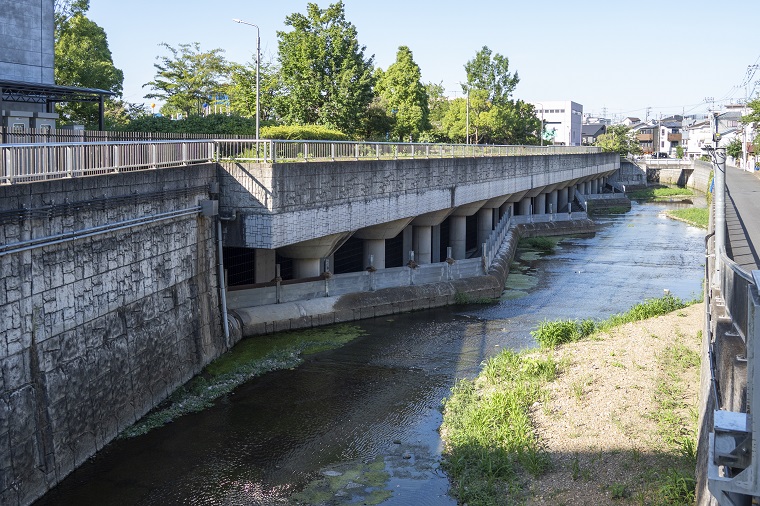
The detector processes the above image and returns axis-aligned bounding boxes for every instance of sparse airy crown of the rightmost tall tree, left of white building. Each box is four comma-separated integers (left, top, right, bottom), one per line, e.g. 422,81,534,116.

462,46,520,105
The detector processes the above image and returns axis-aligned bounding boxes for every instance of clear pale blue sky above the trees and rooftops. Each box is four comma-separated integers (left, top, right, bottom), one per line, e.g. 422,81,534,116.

88,0,760,119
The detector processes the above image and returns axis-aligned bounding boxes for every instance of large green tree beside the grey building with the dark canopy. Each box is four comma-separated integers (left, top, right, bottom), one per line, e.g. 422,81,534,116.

54,12,124,128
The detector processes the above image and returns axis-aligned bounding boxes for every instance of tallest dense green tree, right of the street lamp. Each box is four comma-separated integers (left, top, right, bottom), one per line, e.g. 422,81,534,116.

277,2,374,134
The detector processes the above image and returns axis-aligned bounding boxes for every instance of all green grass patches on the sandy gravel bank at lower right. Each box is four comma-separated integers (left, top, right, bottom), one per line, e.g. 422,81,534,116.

441,295,699,506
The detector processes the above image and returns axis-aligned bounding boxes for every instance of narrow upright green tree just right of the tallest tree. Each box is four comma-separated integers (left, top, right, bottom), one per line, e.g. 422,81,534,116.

375,46,430,141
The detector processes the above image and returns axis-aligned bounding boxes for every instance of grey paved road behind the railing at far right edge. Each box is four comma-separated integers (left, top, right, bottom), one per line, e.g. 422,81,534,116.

726,166,760,271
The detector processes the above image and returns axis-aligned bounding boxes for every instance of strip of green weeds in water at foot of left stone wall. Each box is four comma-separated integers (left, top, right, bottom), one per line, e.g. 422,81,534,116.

119,324,362,438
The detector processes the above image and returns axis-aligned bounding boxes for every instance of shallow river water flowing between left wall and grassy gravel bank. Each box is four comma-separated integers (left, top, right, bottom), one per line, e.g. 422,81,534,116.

35,203,704,506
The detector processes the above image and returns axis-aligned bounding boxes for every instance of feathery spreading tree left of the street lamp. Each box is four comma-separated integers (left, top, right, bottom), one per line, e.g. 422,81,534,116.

143,42,228,116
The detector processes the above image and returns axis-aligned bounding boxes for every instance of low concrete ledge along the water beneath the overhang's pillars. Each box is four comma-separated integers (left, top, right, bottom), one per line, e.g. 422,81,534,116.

230,219,594,337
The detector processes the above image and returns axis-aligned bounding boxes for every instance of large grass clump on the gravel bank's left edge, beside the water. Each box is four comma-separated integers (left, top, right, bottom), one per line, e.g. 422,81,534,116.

441,350,557,506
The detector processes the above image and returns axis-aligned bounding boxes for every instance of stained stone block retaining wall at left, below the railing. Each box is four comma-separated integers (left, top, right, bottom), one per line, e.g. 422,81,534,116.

0,165,228,505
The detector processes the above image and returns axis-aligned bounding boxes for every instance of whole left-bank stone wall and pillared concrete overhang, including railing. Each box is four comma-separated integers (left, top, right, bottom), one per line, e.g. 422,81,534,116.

0,140,619,504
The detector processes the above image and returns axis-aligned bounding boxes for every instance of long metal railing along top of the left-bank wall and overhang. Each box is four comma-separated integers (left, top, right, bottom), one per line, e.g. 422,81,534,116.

0,139,601,184
